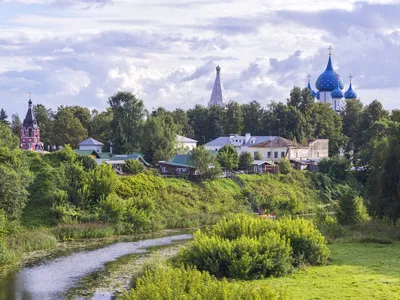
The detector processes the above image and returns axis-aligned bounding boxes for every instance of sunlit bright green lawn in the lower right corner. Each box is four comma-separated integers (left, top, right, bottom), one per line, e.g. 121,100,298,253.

251,243,400,300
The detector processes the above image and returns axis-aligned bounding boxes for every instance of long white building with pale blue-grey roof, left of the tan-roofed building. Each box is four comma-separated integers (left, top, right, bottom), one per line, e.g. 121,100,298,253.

204,133,276,155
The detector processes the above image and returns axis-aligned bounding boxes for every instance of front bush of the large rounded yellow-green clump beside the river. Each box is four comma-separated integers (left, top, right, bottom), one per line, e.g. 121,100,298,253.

181,232,292,279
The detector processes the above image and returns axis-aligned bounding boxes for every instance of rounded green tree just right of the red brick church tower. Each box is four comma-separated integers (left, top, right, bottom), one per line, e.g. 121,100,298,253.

52,107,88,148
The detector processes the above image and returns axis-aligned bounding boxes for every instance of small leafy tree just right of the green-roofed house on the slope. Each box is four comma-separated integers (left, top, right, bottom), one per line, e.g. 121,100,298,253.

189,146,221,179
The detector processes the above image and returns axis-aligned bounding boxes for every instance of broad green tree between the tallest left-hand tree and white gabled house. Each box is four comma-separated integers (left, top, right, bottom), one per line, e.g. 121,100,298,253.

141,114,177,164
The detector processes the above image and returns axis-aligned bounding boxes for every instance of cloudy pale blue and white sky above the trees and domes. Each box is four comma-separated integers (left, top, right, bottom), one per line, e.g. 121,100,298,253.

0,0,400,117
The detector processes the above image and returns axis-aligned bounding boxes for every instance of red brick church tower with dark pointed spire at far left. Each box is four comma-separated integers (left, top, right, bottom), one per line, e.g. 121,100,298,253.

20,97,43,151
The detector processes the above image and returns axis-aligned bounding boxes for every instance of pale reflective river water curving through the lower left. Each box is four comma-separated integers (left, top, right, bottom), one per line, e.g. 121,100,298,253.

0,234,192,300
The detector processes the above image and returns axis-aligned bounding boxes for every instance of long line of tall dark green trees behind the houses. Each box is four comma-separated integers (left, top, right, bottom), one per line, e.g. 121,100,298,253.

0,87,389,163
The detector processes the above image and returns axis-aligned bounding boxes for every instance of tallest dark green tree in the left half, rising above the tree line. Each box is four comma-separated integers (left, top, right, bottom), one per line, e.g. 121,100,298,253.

108,92,147,153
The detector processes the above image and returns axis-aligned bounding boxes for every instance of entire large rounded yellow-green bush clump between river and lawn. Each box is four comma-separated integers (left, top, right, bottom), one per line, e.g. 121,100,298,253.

180,215,329,279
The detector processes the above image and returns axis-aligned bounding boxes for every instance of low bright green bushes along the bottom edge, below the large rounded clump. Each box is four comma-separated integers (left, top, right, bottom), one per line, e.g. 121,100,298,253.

121,266,282,300
